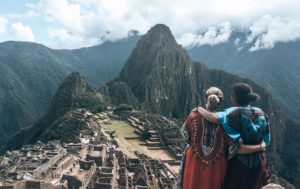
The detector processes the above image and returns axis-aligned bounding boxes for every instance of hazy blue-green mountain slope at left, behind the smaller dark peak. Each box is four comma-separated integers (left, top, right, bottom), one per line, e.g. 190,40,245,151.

0,36,139,138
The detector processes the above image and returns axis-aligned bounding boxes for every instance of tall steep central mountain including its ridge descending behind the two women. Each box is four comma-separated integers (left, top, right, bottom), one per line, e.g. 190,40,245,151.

105,24,300,186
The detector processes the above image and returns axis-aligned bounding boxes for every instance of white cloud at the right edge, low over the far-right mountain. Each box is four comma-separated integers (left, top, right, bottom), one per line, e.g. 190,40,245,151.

247,15,300,51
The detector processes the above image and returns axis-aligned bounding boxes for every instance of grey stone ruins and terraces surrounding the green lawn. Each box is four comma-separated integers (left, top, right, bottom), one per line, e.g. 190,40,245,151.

0,110,185,189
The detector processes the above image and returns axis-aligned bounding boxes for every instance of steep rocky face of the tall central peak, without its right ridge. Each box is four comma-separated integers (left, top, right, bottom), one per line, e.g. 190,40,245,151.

115,25,199,118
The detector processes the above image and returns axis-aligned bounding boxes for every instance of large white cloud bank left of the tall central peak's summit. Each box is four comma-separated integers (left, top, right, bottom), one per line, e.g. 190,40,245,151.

29,0,152,48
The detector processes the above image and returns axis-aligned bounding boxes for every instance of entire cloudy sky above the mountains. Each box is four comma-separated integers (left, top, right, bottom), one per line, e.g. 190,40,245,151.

0,0,300,50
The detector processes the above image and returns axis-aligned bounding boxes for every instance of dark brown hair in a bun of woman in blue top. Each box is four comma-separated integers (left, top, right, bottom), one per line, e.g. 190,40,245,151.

232,83,260,106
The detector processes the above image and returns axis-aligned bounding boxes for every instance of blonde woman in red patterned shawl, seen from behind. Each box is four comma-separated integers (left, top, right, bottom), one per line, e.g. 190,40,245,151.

179,87,265,189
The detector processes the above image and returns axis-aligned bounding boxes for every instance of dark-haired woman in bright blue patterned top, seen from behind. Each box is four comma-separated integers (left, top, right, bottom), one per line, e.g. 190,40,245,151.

198,83,270,189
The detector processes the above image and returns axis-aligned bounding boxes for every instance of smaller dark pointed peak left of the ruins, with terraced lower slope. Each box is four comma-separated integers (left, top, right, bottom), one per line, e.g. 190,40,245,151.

0,72,103,152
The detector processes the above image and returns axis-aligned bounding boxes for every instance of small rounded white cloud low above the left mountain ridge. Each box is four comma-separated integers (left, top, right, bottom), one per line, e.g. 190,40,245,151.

11,22,35,42
